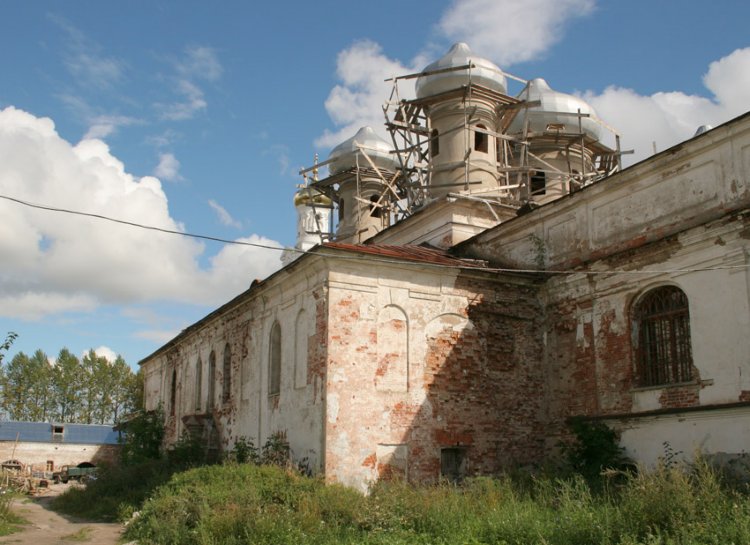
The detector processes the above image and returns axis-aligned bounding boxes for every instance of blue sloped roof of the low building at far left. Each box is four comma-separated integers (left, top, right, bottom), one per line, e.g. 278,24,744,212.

0,422,118,445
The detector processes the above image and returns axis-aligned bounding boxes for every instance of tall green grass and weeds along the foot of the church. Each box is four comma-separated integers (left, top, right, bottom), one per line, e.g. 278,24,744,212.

51,463,750,545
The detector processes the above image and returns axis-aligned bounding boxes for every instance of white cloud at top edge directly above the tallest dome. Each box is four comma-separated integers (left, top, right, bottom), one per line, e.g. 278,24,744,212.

438,0,596,68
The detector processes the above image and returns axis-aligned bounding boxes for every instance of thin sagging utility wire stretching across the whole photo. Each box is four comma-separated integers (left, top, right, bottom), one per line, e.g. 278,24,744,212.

0,194,750,275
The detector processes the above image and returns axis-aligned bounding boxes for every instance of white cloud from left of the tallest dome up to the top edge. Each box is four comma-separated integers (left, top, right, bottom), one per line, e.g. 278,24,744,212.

315,0,595,147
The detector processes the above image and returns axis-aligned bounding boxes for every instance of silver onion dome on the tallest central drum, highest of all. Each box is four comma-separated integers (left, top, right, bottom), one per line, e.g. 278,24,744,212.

416,42,508,98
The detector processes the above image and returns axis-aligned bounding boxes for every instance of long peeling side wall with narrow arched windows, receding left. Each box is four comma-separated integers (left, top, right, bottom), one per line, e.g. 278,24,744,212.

143,260,327,472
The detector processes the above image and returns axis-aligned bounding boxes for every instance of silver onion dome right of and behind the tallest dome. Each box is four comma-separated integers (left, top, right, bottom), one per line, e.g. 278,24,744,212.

508,78,602,140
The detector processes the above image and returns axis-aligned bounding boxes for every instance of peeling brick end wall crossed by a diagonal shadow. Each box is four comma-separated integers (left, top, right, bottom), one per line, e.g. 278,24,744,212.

326,263,545,489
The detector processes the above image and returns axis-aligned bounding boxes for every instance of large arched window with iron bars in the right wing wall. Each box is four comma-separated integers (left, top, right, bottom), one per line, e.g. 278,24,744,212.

633,286,693,386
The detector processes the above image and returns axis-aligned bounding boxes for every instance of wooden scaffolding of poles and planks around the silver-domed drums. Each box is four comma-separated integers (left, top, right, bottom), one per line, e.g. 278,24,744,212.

300,63,632,241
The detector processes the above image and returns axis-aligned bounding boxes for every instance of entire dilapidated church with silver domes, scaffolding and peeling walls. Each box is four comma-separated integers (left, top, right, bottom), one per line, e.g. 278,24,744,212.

141,43,750,490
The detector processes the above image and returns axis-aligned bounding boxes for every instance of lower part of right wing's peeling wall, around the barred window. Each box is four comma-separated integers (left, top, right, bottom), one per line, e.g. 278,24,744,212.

544,214,750,454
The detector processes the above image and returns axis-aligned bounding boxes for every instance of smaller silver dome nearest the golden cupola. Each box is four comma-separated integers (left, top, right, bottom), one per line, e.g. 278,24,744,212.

328,127,399,175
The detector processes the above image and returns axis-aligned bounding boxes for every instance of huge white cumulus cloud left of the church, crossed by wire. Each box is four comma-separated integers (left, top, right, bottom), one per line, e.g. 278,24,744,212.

0,107,280,319
